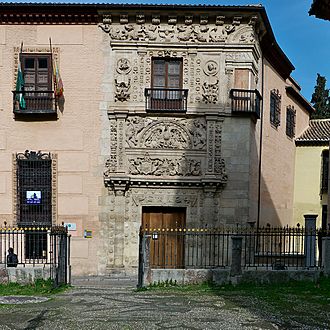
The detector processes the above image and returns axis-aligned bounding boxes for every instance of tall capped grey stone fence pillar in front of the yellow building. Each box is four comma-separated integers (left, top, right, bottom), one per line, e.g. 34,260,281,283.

304,214,317,268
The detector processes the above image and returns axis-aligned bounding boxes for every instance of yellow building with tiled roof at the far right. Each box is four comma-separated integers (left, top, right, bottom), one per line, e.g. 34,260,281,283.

294,119,330,228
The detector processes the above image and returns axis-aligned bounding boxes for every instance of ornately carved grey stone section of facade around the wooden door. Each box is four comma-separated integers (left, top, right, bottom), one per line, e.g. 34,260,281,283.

99,11,261,270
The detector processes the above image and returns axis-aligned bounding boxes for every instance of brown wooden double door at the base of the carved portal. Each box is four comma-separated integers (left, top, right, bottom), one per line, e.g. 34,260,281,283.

142,207,186,268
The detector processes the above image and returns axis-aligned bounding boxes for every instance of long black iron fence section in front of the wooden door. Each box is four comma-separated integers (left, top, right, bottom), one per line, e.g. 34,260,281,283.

140,225,321,270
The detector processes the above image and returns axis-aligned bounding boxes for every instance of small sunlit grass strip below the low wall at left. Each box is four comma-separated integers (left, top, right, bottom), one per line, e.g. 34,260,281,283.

0,279,69,296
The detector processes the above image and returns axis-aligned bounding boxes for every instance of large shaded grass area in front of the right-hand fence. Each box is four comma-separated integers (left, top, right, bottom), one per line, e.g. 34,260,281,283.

148,277,330,329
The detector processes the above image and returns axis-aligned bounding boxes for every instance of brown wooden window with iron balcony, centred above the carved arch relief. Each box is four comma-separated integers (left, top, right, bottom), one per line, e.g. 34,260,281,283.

145,58,188,112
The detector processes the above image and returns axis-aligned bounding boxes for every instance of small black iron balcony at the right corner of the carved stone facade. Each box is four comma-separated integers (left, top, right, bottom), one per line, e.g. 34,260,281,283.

230,89,262,119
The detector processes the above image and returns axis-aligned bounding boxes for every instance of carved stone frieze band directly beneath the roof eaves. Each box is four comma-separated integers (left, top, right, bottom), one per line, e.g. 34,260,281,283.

99,15,257,43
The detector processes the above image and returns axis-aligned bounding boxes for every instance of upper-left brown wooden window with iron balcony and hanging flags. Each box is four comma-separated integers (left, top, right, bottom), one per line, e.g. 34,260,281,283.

13,53,56,115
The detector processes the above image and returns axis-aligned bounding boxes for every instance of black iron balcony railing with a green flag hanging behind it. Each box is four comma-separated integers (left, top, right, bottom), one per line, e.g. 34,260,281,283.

13,91,57,114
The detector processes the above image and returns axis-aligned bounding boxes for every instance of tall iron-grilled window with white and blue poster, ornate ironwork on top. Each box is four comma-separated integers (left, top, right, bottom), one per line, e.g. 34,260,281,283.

16,150,52,226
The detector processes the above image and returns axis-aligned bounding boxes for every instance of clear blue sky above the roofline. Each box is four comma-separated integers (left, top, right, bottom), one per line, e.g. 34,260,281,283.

4,0,330,100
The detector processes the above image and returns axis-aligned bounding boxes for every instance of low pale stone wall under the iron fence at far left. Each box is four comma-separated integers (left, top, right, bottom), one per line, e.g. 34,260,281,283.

0,267,50,284
